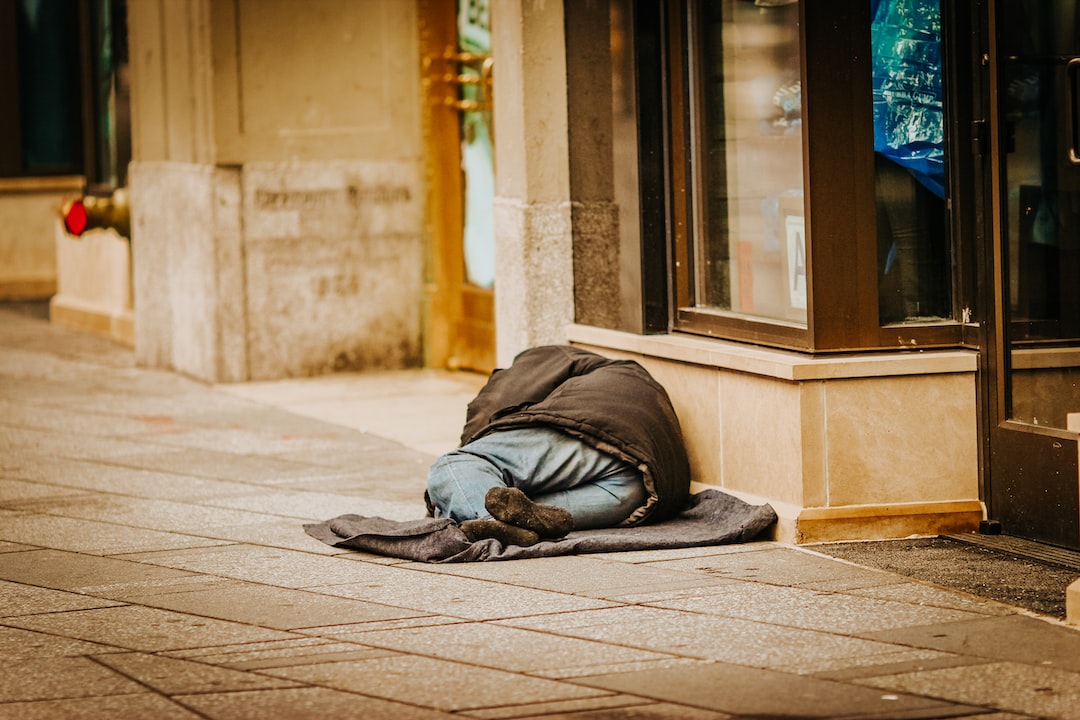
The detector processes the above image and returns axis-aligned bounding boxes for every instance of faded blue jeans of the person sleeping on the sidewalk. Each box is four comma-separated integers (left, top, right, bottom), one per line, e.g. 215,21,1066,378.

428,427,648,530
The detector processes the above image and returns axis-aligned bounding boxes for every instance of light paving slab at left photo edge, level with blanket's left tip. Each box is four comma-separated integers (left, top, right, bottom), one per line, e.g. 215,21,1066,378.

0,515,231,555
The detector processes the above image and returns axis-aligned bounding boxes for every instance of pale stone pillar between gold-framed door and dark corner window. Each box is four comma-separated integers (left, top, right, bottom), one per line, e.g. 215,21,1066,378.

491,0,573,367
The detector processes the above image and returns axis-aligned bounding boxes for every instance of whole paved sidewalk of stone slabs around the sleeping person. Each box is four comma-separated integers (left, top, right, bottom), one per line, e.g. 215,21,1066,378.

6,309,1080,720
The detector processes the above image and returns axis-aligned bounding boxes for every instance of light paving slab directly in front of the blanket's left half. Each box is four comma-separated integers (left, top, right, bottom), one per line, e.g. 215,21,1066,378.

308,562,611,620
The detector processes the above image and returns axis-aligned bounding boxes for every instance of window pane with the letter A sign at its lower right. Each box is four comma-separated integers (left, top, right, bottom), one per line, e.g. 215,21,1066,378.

688,0,807,324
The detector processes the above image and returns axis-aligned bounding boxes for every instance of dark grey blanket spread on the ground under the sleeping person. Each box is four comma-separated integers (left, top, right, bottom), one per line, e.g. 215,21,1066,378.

303,490,777,562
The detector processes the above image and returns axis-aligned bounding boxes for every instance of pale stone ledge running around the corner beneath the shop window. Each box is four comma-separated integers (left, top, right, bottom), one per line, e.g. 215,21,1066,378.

566,325,978,382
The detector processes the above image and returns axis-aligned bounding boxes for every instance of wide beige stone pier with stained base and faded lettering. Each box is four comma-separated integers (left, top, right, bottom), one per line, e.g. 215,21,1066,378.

129,0,423,382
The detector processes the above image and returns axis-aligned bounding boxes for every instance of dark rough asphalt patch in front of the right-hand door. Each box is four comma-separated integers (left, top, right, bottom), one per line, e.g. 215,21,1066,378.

809,536,1080,620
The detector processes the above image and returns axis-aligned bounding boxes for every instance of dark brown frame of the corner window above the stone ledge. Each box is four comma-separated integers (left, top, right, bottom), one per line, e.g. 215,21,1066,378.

662,0,977,353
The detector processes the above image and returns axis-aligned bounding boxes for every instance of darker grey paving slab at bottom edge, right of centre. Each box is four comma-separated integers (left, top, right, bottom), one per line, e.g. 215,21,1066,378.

579,663,978,718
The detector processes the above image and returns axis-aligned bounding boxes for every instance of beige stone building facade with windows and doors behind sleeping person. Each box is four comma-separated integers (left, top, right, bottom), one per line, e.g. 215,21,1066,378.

0,0,1080,547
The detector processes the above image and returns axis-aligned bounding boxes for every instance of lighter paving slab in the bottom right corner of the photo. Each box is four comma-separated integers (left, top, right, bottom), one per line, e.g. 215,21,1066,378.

859,662,1080,720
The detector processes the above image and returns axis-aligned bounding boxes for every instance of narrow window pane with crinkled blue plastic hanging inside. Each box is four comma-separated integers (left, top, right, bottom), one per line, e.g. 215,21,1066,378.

870,0,951,324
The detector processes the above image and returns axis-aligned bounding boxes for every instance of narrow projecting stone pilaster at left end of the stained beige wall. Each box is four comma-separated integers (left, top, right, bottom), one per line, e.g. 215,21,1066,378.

129,0,220,381
